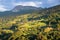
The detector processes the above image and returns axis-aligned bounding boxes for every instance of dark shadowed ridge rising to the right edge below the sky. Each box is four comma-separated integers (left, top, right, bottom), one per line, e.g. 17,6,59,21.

40,5,60,15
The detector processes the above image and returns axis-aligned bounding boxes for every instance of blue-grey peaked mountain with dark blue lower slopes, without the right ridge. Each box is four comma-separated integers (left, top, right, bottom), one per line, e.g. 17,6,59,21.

0,5,43,17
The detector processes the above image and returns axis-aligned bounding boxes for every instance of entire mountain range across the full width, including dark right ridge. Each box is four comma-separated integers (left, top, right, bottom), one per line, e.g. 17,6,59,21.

0,5,60,17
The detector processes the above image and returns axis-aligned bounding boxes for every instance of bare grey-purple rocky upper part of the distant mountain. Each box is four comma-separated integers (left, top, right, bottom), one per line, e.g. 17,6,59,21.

12,5,42,12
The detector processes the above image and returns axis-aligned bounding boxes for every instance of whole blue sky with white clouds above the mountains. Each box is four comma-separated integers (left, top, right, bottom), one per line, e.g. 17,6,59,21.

0,0,60,11
